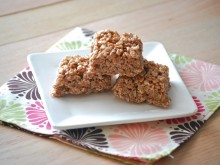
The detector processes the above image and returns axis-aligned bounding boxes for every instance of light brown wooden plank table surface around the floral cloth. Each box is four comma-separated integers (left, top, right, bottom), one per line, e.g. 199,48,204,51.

0,0,220,165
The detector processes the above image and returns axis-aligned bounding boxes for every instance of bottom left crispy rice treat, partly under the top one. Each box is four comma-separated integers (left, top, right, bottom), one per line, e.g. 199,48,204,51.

52,55,112,97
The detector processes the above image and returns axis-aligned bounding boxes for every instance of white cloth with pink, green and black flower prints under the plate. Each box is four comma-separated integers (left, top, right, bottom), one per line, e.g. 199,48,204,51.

0,28,220,164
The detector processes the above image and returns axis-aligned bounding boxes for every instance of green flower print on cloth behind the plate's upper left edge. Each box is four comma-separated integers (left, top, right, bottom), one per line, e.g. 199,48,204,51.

57,41,88,51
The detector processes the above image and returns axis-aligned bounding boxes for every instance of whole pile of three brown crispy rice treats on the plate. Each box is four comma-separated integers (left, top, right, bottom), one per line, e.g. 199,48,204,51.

52,30,171,108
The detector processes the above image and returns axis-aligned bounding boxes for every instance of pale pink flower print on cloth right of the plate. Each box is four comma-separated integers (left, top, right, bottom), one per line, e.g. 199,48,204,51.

180,61,220,91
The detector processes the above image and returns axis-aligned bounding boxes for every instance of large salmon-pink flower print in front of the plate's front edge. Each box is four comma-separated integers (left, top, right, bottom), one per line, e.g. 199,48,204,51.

109,123,169,157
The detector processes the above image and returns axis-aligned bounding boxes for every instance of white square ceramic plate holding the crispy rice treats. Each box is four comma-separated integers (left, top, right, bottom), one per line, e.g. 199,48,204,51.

28,42,197,129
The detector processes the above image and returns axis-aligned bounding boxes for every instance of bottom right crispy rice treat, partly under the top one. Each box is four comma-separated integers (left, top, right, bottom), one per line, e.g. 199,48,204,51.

113,60,171,108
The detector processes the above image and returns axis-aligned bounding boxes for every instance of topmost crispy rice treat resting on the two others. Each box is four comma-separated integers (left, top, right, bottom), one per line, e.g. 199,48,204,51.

90,30,144,77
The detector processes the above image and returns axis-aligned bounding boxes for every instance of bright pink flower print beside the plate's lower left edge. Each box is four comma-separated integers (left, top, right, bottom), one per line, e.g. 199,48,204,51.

26,101,51,130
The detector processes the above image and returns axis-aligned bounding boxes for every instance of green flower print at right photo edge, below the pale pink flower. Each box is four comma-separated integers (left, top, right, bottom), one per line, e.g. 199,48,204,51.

205,90,220,112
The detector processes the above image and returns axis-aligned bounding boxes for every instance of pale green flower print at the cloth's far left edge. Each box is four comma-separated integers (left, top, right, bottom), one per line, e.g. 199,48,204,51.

0,100,26,124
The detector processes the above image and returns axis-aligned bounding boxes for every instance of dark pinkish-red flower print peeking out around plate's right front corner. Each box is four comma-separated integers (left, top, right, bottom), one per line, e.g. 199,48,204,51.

166,96,205,124
